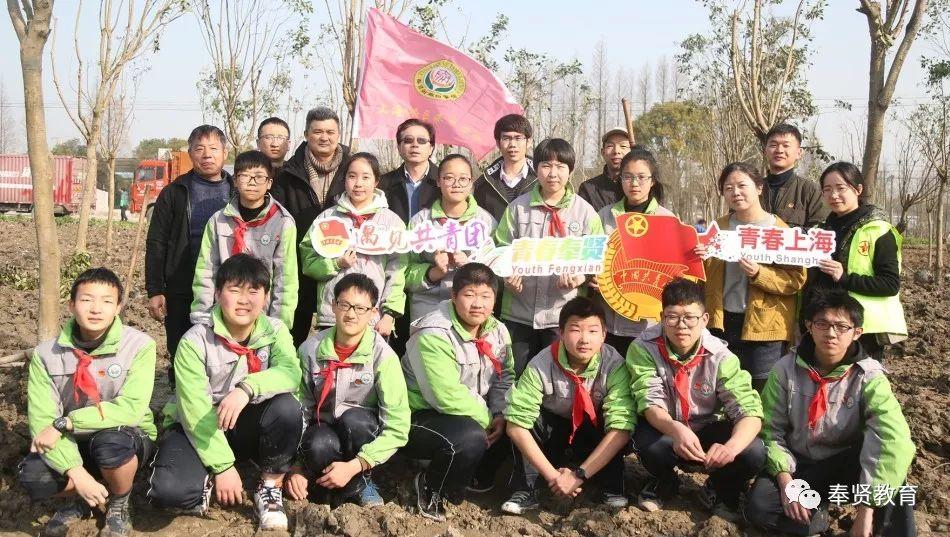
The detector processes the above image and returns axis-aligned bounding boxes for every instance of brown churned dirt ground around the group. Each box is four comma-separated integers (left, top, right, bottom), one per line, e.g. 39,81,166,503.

0,217,950,537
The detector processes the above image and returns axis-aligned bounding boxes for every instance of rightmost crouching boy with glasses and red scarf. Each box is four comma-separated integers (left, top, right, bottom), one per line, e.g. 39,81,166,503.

745,289,917,537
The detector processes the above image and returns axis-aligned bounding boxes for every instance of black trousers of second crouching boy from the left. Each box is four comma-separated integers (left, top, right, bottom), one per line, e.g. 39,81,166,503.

147,393,303,509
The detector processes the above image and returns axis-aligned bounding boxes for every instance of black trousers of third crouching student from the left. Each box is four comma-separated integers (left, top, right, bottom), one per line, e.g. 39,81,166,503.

300,408,383,498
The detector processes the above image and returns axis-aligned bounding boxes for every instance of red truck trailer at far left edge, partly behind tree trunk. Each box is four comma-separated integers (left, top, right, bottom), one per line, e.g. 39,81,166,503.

0,155,88,215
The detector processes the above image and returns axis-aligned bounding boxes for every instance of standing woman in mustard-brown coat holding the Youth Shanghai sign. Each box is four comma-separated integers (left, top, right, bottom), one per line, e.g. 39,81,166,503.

696,162,805,390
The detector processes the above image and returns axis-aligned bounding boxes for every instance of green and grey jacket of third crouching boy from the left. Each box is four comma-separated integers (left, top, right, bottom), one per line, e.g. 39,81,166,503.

297,327,409,466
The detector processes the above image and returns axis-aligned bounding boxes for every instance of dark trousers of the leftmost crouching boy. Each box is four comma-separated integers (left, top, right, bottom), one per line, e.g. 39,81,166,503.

19,427,155,501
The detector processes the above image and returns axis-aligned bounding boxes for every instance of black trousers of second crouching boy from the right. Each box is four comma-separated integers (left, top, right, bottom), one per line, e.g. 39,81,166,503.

633,419,766,508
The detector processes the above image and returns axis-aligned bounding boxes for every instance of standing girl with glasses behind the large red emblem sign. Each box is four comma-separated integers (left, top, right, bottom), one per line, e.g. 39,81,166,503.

597,148,674,354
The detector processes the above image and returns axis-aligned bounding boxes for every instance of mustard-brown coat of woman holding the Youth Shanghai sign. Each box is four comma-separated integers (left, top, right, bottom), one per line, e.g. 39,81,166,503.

703,214,806,341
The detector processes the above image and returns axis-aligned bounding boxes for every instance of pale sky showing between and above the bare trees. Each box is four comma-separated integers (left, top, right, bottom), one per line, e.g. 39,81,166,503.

0,0,927,168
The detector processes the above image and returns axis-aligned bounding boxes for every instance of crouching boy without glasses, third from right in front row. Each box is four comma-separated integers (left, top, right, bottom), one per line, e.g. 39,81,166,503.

501,297,636,515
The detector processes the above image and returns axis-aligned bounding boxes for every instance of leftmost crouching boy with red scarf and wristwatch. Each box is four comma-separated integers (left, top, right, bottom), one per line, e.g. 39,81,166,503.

19,268,156,536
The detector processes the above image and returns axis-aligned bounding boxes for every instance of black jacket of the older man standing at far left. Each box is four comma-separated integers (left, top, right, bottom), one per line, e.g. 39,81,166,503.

145,170,234,298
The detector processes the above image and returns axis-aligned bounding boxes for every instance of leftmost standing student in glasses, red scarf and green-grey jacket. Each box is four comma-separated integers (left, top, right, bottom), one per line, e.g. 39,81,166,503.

191,151,297,328
